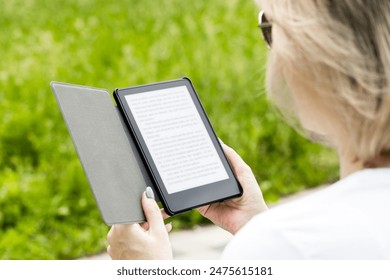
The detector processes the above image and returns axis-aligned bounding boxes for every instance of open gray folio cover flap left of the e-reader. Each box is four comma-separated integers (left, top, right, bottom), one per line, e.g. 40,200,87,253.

51,82,152,225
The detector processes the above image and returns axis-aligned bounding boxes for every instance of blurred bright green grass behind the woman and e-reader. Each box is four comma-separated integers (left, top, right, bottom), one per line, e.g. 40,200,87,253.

0,0,337,259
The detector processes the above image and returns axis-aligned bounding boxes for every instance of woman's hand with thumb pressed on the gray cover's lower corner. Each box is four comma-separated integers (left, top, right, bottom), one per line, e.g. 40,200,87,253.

107,187,172,260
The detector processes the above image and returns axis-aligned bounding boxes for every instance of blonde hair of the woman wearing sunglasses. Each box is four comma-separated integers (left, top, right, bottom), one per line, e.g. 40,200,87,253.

258,0,390,166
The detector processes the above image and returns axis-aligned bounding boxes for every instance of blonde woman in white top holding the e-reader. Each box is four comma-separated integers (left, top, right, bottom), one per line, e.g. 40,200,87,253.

108,0,390,259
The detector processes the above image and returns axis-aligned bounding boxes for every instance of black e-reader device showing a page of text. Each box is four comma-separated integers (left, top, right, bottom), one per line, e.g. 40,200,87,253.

114,78,242,215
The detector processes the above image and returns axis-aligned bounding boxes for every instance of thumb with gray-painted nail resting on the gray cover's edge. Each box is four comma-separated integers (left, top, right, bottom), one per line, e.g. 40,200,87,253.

142,187,166,233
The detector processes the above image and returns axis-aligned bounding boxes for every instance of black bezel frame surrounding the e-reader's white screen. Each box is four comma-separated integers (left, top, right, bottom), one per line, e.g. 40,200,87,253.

114,78,242,215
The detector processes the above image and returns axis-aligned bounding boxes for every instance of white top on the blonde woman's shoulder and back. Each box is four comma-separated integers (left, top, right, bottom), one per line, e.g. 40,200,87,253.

222,168,390,259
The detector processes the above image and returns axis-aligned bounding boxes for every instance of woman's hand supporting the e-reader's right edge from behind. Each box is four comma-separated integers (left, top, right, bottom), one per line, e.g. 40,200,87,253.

198,143,268,234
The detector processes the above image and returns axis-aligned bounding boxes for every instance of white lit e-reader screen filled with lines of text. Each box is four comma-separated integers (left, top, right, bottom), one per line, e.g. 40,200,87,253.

125,86,229,193
